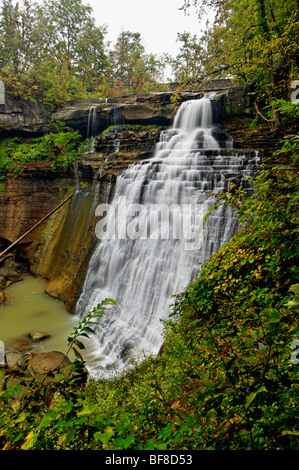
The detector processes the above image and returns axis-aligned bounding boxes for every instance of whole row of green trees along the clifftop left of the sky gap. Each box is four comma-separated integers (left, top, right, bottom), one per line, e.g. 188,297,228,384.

0,0,169,105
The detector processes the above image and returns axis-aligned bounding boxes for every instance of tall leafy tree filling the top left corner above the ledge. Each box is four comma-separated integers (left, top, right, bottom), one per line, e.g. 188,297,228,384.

0,0,107,107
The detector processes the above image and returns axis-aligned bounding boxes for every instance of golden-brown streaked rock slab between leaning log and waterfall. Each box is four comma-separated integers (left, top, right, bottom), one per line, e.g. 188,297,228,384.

31,183,103,312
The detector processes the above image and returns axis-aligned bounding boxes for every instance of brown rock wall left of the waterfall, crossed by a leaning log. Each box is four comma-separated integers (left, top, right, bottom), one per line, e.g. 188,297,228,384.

0,166,97,311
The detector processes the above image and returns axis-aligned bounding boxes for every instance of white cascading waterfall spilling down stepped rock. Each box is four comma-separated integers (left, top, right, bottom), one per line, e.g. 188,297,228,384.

77,97,258,377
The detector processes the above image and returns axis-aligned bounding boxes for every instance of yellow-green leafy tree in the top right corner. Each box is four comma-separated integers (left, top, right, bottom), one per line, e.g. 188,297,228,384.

184,0,299,103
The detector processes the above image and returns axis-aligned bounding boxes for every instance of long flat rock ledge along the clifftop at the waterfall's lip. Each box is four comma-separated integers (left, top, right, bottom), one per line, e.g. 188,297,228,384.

0,86,253,137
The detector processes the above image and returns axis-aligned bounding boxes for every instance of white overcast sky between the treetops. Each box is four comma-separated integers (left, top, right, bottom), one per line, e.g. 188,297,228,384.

83,0,207,57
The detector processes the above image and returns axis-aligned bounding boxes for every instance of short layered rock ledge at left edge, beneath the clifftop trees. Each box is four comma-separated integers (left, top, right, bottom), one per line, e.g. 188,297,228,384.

0,98,50,136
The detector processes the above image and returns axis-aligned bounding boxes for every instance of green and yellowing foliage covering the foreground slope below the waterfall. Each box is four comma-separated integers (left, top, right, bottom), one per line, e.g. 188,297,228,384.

0,136,299,450
